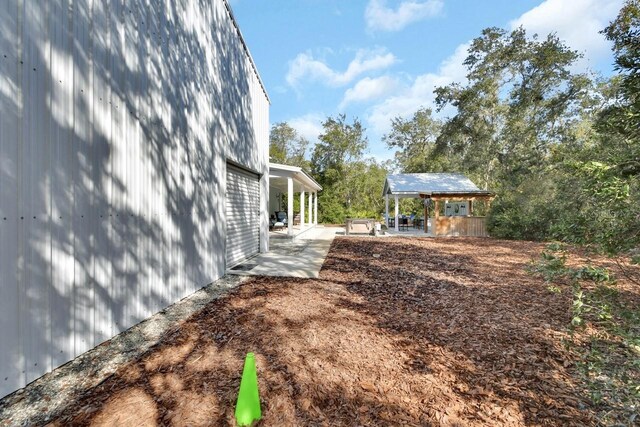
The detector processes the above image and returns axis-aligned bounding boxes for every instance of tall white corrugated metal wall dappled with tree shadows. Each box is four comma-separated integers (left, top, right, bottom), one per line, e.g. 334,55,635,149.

0,0,269,396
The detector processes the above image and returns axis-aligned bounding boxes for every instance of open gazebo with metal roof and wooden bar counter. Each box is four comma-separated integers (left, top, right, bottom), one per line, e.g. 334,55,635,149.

383,173,495,236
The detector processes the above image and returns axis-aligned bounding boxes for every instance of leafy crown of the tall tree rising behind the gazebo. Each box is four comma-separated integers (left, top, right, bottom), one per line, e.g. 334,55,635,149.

435,24,590,192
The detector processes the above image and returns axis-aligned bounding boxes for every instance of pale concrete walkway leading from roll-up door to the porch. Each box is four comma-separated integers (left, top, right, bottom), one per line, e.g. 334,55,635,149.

227,225,344,278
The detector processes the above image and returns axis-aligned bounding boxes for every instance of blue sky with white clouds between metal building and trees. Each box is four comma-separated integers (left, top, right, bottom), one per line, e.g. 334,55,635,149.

231,0,622,160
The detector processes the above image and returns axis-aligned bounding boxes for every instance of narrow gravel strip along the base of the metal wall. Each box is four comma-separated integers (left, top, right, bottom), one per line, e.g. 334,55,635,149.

0,275,248,426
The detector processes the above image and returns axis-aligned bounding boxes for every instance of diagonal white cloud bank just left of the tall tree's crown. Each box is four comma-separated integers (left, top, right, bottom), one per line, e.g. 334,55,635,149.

367,43,469,135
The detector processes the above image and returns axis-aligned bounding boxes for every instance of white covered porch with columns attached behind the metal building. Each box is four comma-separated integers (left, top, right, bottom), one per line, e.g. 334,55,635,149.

269,163,322,238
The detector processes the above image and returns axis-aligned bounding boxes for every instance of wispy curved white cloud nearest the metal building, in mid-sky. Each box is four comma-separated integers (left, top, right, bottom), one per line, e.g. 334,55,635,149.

286,49,396,87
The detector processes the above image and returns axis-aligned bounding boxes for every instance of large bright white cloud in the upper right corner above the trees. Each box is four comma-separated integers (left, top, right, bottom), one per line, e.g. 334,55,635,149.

509,0,622,67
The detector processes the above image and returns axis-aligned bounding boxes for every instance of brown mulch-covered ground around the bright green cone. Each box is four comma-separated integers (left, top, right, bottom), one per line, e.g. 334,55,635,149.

40,238,636,426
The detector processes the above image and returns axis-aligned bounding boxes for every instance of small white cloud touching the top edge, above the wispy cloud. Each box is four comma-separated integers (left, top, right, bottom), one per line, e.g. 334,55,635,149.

364,0,443,31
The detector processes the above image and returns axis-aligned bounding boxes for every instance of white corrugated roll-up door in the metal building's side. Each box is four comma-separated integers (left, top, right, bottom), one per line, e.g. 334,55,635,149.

227,164,260,268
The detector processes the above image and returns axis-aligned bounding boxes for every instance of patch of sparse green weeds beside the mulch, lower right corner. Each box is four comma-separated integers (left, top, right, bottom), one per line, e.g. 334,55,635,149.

529,243,640,425
